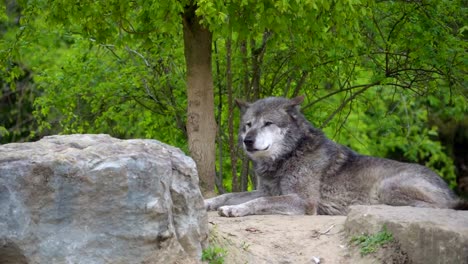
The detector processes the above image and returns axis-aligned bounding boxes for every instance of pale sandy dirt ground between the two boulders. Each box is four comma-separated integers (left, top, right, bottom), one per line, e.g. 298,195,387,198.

209,212,374,264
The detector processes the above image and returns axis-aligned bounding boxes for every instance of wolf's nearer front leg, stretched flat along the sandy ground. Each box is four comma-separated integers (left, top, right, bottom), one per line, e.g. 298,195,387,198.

218,194,316,217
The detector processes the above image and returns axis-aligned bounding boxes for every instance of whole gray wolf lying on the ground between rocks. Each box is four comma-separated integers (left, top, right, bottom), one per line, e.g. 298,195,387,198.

205,97,459,217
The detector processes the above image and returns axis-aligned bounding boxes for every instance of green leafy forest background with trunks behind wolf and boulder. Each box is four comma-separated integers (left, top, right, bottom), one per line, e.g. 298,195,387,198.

0,0,468,195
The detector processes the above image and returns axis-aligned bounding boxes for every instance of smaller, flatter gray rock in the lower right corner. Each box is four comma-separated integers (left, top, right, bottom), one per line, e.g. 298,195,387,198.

345,205,468,264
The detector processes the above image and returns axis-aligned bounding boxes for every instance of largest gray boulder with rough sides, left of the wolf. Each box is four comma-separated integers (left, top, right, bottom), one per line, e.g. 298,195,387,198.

0,135,208,264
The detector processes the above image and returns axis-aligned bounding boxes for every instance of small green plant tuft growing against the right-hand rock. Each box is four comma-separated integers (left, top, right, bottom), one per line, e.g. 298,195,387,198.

351,226,393,256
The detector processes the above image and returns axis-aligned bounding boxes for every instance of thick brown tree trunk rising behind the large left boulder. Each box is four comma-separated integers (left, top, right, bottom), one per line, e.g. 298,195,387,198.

182,4,216,196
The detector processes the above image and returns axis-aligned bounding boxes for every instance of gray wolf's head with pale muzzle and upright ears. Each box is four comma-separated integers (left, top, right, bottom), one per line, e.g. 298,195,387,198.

236,97,305,160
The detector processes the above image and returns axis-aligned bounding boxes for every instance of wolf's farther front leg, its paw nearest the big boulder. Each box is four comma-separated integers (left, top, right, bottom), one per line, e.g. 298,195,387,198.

205,190,266,211
